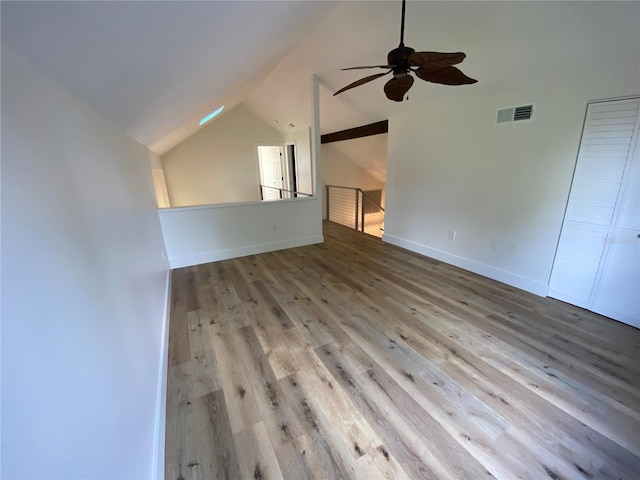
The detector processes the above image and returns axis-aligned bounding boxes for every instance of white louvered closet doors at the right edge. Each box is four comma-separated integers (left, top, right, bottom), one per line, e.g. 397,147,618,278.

549,99,640,328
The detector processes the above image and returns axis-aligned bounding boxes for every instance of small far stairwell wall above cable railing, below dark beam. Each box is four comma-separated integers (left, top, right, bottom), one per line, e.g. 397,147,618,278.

321,143,385,218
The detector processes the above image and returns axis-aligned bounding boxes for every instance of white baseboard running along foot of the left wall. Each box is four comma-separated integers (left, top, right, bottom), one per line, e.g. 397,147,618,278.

151,270,171,480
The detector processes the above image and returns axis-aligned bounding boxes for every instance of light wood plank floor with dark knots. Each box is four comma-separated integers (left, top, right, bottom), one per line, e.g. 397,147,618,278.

166,224,640,480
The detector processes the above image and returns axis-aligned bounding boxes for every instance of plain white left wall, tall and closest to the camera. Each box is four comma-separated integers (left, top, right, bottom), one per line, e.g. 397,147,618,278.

1,47,168,479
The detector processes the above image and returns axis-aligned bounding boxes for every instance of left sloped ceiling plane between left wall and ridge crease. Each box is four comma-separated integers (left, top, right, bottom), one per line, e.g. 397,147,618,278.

2,1,332,153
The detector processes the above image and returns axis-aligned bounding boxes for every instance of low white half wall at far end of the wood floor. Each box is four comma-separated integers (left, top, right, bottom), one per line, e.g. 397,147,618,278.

160,197,323,268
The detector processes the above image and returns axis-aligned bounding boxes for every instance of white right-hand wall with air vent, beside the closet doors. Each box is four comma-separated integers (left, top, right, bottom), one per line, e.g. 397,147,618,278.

383,87,639,295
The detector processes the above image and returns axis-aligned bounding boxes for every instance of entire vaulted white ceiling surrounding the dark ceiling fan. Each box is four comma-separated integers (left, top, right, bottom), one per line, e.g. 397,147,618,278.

1,0,640,154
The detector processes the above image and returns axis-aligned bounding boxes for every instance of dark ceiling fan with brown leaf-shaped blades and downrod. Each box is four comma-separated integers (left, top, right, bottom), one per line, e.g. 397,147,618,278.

333,0,477,102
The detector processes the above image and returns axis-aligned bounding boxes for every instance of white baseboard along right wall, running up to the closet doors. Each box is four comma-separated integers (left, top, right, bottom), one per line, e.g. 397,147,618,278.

382,233,549,297
